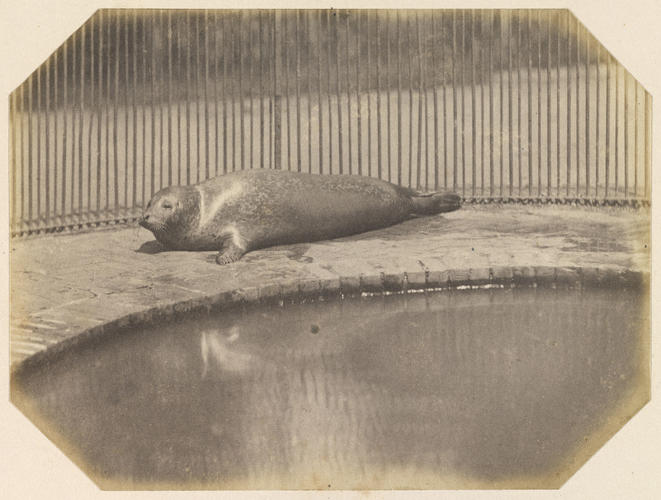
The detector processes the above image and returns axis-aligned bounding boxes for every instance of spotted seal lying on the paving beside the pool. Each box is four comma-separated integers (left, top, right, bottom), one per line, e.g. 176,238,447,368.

140,169,461,264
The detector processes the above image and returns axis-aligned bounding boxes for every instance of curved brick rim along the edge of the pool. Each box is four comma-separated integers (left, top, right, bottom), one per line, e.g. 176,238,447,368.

10,266,650,377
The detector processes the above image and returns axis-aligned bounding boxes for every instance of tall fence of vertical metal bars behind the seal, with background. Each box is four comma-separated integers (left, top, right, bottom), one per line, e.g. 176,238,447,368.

10,10,651,235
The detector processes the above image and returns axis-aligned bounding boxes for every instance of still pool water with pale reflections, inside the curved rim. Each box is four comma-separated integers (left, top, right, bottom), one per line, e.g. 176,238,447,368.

12,288,649,489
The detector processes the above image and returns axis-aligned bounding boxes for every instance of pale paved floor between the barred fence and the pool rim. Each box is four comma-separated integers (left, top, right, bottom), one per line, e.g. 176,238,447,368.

10,205,650,366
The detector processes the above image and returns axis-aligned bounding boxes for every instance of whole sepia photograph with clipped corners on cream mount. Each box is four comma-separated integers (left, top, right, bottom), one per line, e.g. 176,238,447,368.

6,0,655,494
